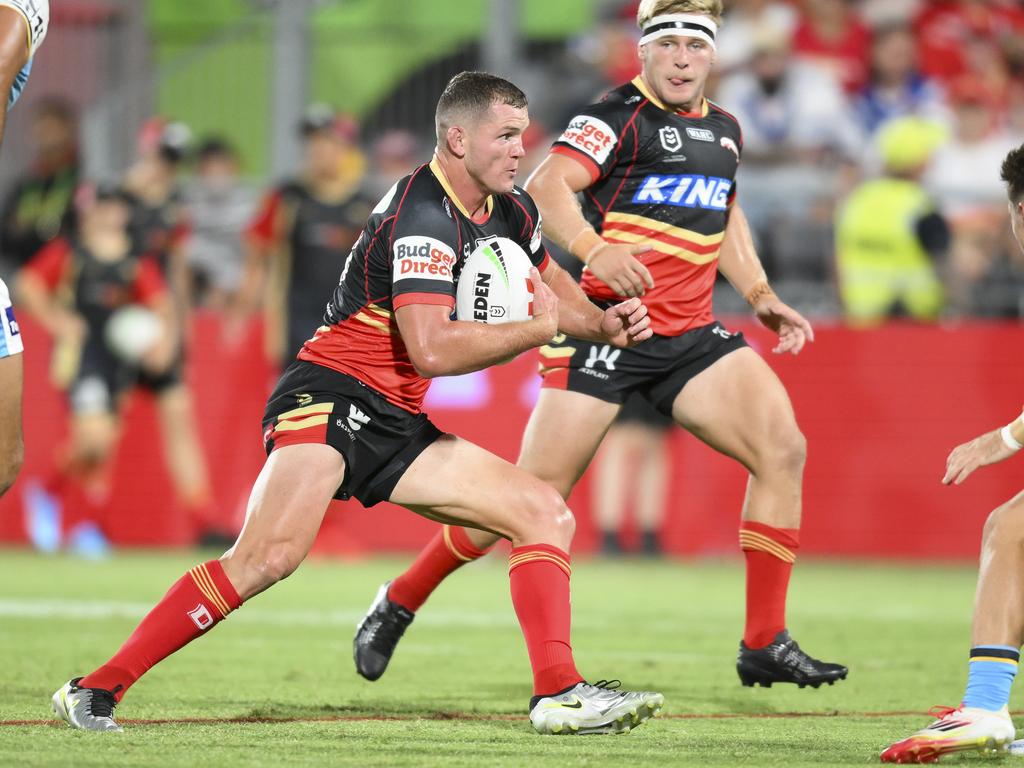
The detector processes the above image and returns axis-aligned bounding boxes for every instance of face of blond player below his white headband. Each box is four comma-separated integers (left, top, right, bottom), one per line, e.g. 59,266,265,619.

640,35,715,112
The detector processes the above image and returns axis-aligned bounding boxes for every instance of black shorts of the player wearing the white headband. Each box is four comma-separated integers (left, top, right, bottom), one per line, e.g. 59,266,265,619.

541,322,748,417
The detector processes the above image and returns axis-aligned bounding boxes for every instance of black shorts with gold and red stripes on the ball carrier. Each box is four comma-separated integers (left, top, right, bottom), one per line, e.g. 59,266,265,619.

263,360,443,507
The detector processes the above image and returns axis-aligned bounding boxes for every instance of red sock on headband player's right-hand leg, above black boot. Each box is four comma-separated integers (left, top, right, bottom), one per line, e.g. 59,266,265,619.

739,520,800,648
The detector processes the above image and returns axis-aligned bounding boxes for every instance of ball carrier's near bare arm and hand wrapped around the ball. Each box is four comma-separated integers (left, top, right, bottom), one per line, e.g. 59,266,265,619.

395,268,558,379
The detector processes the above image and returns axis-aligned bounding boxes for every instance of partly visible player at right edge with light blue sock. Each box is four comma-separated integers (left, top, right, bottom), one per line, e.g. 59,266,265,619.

882,146,1024,763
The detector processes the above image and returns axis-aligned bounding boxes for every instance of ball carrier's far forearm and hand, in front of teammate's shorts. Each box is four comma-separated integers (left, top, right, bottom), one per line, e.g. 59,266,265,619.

543,259,652,347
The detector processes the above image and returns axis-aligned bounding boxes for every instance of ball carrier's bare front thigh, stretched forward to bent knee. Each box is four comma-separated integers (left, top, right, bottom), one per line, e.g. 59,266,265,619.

389,434,572,541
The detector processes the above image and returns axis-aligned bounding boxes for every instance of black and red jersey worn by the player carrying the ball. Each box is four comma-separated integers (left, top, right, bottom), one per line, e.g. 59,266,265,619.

298,159,548,413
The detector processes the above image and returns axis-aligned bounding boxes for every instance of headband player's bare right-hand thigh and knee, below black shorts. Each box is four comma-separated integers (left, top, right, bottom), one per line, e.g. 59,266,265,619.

672,347,805,473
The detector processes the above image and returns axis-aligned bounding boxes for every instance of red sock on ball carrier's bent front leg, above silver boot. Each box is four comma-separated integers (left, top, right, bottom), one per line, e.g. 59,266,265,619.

509,544,583,695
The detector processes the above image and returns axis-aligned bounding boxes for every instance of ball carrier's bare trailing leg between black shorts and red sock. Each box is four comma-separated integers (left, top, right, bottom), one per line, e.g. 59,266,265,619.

223,443,345,599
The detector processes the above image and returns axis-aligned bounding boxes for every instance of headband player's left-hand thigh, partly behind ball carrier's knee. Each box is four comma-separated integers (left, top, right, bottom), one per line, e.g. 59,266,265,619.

517,389,622,499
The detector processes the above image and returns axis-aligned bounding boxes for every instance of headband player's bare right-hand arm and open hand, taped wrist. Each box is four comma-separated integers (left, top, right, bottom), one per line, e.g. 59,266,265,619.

718,205,814,354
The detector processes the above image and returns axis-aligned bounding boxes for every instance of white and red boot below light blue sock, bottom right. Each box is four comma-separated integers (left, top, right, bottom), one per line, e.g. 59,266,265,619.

882,707,1017,763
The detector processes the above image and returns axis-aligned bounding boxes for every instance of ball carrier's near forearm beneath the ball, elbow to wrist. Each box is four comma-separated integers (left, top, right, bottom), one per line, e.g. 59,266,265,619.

413,321,550,379
